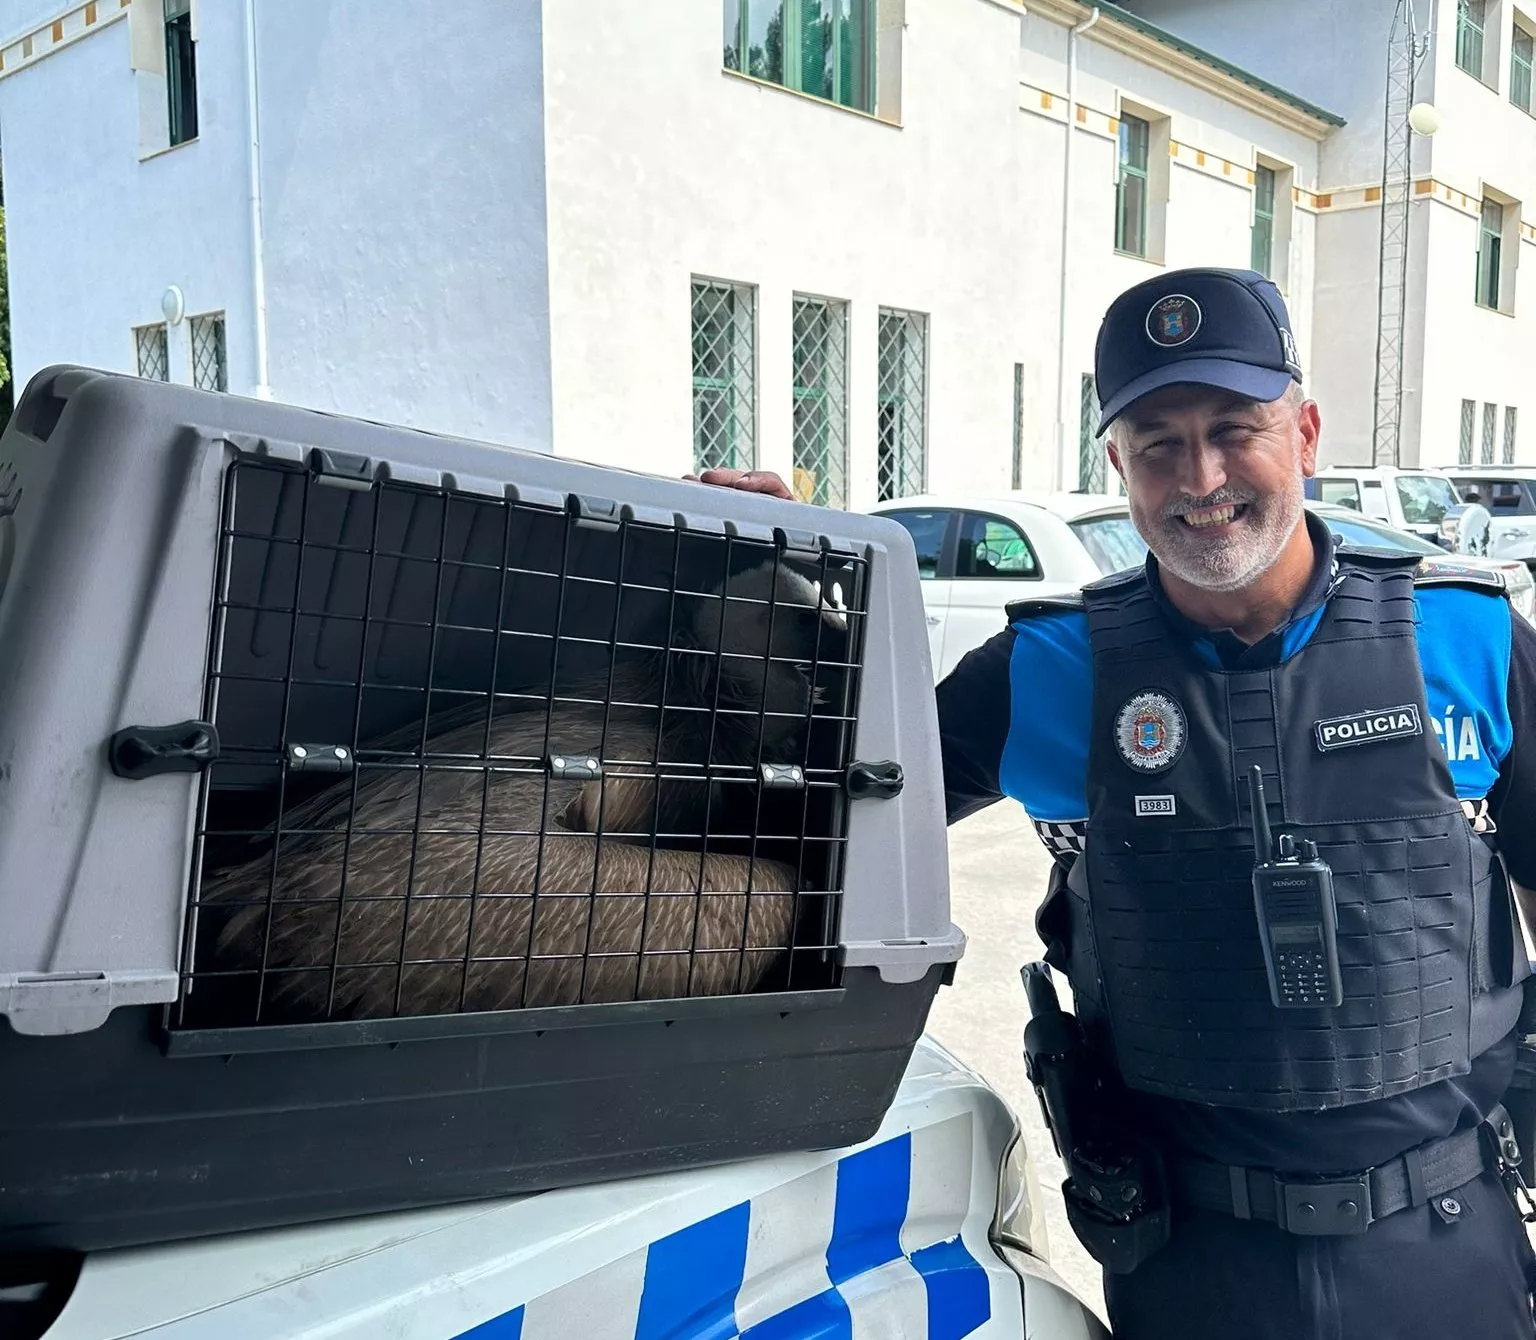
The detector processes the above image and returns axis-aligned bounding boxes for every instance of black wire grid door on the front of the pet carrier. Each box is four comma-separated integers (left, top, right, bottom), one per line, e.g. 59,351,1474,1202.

170,456,868,1030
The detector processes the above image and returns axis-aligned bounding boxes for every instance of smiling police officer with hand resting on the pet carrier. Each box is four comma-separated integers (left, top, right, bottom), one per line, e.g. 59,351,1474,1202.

702,269,1536,1340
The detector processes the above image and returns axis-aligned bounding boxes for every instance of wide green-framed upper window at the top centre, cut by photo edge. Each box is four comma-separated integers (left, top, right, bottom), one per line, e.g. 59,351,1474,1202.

723,0,877,114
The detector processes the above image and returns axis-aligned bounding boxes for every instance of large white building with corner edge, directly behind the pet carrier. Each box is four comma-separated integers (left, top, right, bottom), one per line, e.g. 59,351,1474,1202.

0,0,1342,507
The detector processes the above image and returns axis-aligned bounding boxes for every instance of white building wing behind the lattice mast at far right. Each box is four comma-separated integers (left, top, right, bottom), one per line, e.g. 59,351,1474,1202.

1127,0,1536,466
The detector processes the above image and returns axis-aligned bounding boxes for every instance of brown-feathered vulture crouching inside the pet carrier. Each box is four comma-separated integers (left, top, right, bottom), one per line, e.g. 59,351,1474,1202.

197,561,848,1023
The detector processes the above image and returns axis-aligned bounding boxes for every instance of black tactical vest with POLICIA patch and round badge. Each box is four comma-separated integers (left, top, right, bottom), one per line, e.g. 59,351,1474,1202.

1041,549,1530,1111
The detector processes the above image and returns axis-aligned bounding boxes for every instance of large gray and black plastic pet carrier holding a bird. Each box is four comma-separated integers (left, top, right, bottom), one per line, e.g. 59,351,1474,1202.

0,367,963,1251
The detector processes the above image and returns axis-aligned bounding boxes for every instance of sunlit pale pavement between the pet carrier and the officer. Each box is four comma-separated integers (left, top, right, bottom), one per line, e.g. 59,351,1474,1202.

928,801,1107,1323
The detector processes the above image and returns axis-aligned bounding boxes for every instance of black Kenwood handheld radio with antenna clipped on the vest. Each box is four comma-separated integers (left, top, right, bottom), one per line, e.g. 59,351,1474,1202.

1249,767,1344,1010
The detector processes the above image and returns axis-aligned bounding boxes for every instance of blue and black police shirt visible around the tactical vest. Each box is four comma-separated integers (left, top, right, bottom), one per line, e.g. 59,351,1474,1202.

938,513,1536,1171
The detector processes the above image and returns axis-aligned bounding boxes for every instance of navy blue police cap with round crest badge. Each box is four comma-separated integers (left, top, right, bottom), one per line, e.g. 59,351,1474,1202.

1094,269,1301,436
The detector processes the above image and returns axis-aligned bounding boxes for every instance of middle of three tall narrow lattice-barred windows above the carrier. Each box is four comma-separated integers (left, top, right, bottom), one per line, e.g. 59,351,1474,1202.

793,295,848,507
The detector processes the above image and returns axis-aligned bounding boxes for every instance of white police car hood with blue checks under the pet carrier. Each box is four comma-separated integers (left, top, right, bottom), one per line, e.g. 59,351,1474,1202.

21,1037,1107,1340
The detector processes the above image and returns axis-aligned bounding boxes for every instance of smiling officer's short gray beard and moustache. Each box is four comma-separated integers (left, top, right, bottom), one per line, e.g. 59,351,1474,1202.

1132,478,1303,592
